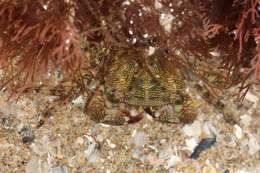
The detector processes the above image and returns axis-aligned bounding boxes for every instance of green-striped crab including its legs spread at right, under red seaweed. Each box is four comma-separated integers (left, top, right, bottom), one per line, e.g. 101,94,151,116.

85,41,248,125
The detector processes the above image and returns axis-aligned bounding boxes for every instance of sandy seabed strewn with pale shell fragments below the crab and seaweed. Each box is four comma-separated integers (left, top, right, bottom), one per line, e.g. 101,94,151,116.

0,83,260,173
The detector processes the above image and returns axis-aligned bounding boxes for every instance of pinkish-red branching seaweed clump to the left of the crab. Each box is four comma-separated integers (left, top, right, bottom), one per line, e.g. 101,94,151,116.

0,0,97,96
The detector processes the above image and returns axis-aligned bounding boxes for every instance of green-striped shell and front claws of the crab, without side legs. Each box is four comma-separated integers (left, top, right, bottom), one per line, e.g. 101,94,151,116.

86,53,201,125
